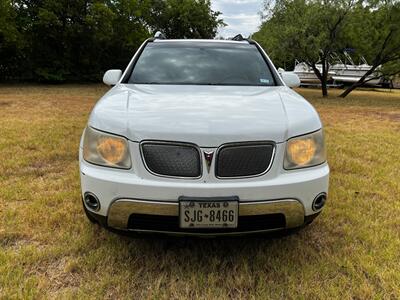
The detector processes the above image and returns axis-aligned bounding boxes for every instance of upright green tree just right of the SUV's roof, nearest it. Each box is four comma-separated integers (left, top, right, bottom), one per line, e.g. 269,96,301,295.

253,0,354,96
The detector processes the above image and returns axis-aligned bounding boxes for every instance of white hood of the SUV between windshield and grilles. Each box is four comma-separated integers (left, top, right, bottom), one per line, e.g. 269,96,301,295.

89,84,321,147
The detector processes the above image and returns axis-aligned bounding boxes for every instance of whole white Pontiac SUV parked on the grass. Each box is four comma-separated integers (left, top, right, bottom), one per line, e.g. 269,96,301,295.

79,38,329,235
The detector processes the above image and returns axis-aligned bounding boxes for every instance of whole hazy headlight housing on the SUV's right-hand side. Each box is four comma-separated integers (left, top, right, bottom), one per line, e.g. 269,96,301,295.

284,129,326,170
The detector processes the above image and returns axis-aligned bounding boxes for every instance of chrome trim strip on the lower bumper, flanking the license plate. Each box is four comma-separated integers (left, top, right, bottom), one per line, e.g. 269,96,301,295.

107,199,305,231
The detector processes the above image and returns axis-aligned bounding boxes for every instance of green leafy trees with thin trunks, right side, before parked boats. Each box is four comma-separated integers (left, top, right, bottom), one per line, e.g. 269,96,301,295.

253,0,400,96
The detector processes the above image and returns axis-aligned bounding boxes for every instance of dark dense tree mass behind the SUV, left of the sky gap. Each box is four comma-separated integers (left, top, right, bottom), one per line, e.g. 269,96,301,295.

0,0,223,82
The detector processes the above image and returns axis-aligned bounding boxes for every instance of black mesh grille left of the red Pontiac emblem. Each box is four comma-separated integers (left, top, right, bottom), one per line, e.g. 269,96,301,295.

142,143,201,177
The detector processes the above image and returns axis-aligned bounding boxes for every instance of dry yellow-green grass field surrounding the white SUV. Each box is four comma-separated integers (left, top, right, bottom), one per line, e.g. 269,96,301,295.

0,85,400,299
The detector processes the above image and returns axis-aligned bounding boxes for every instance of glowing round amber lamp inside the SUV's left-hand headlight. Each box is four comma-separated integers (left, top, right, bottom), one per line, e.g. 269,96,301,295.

97,137,126,164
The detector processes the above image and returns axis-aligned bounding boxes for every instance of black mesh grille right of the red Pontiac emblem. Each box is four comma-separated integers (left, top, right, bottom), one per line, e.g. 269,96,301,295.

215,144,274,177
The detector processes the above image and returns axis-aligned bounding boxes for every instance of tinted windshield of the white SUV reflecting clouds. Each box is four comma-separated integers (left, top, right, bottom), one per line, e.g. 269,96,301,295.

128,42,275,86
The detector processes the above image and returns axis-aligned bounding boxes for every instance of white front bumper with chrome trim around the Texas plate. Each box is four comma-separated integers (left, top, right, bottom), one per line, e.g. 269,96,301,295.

80,145,329,235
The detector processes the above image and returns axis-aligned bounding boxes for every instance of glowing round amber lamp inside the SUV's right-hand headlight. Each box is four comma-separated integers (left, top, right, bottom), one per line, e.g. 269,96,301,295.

288,138,317,166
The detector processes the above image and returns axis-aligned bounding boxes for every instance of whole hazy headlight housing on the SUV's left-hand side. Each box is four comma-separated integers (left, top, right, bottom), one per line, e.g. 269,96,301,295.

83,127,131,169
